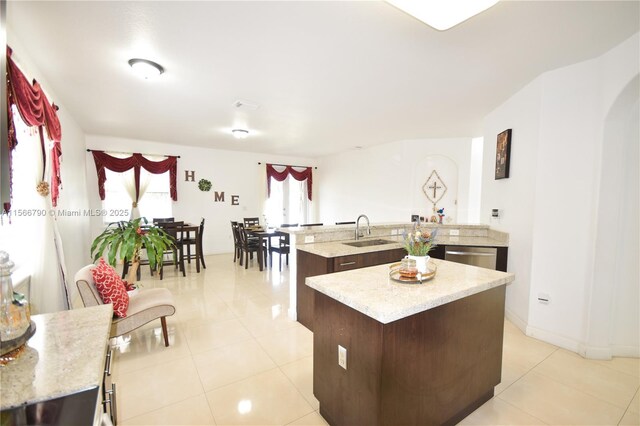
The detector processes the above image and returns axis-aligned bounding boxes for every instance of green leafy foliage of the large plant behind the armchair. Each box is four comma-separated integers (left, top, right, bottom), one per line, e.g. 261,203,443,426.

91,218,173,283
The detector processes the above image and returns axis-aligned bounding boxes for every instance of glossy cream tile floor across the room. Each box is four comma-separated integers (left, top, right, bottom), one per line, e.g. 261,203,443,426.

113,255,640,426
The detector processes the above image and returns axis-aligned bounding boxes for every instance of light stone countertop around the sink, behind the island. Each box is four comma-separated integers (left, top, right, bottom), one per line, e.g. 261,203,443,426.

296,235,509,258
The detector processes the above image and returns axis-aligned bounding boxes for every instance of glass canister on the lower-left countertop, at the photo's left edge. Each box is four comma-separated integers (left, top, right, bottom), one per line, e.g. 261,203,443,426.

0,251,31,355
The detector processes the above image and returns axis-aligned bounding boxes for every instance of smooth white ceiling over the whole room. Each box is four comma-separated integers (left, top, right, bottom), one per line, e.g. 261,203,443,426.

7,1,640,157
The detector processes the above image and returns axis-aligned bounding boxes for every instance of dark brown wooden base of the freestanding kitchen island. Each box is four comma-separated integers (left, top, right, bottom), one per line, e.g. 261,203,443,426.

313,285,506,426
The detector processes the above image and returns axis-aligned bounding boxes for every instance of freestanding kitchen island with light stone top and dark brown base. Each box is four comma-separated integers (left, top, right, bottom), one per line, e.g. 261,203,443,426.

306,260,514,425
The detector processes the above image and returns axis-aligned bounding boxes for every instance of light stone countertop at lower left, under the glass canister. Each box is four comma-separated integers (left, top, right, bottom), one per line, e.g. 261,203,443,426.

0,305,113,410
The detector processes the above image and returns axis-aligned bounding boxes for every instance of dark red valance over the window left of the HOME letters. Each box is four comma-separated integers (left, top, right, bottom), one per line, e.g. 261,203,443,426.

91,151,178,203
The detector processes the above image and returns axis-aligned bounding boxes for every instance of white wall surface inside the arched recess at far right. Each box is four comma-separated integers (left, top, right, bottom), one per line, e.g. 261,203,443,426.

585,76,640,357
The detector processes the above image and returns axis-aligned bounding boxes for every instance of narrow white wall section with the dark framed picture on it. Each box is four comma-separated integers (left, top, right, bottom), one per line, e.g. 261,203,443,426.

480,81,540,327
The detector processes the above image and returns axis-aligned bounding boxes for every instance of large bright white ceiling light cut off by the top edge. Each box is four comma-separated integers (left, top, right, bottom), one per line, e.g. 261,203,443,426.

387,0,498,31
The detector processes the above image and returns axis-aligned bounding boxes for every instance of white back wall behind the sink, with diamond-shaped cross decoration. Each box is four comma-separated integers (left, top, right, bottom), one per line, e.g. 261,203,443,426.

318,138,471,224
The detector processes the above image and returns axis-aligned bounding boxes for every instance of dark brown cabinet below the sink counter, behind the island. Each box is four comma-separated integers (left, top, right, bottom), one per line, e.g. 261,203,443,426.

296,248,407,331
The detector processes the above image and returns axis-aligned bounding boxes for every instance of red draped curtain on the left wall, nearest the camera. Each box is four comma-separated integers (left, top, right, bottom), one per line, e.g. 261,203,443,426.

7,46,62,207
